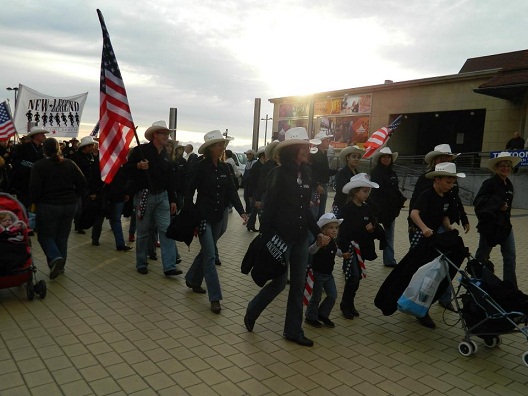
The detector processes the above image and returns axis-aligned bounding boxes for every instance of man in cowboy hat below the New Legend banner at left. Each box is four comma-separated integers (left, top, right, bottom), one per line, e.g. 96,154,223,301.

11,126,49,208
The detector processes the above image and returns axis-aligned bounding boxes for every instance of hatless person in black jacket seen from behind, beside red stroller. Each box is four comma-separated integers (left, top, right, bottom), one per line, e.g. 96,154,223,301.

29,138,86,279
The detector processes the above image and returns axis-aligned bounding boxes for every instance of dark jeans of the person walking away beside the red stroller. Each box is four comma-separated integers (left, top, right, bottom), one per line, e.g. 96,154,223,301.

37,202,77,264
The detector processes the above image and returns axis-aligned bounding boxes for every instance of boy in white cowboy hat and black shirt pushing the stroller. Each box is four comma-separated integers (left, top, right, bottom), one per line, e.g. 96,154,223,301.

410,162,466,329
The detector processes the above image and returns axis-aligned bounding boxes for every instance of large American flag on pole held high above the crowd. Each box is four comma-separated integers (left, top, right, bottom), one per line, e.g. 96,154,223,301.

97,10,135,184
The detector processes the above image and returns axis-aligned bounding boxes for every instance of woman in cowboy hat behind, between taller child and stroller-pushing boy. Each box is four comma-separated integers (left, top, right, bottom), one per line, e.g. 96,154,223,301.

369,147,405,267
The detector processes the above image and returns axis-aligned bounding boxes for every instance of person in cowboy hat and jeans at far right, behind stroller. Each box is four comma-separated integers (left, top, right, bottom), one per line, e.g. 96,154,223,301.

473,151,520,289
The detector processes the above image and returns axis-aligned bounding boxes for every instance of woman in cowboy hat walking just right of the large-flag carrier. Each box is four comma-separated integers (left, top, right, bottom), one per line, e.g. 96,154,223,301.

185,130,247,313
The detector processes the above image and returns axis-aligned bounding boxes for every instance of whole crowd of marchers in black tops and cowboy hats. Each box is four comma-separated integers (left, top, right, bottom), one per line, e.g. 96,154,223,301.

0,124,524,346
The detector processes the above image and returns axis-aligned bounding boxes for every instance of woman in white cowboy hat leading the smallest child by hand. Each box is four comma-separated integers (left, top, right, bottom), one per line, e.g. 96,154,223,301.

244,128,330,346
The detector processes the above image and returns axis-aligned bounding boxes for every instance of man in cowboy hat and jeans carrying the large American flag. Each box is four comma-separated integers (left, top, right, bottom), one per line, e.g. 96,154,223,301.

125,123,182,276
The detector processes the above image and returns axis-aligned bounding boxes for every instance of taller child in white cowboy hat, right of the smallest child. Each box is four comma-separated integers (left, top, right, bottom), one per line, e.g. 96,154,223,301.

338,173,384,319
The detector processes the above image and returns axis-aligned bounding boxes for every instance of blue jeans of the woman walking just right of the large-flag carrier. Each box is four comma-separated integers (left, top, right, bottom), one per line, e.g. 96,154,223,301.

185,221,223,301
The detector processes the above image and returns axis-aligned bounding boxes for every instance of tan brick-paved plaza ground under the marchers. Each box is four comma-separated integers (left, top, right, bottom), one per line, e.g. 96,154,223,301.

0,196,528,396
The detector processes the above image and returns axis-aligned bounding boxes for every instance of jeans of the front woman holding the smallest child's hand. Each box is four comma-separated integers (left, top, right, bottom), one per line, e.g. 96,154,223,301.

246,236,308,339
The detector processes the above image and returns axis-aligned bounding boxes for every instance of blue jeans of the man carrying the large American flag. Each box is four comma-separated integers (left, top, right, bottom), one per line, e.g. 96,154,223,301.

134,191,176,272
